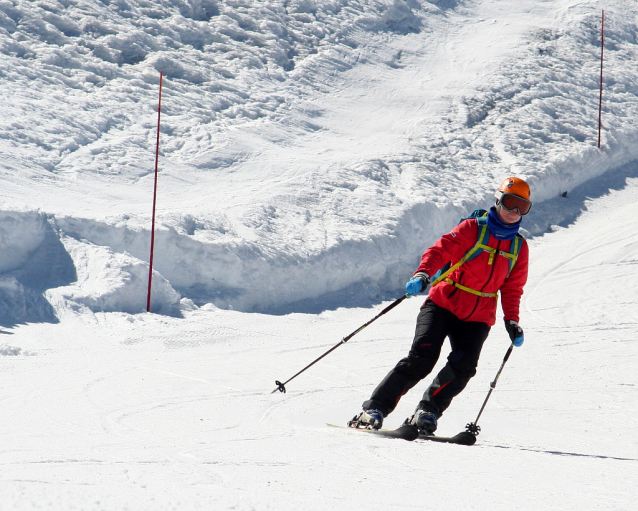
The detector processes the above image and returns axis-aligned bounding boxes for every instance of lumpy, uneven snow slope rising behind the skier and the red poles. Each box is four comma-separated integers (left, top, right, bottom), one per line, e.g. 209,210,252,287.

0,0,638,319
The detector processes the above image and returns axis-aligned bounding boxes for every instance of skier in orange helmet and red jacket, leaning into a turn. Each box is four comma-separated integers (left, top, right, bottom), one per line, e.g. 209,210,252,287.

348,177,532,435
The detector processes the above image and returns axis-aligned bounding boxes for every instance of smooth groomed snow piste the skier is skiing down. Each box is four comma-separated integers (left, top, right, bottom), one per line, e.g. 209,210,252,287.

0,168,638,510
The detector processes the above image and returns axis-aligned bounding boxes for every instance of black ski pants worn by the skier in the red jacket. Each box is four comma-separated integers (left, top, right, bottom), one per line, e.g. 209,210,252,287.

363,300,490,417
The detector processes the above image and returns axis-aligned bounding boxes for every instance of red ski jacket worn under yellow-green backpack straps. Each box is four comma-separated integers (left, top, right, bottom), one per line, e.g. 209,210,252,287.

415,218,529,326
